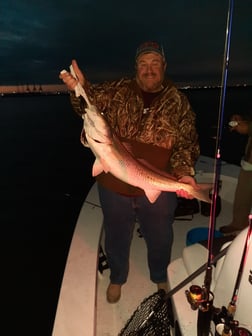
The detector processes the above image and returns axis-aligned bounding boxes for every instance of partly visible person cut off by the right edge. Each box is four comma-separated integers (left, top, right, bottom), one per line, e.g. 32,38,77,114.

220,114,252,235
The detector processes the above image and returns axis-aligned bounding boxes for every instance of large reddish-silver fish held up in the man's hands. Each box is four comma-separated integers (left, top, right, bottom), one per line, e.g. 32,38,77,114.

83,105,212,203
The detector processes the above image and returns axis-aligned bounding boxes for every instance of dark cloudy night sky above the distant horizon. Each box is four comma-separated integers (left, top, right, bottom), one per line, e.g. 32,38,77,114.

0,0,252,85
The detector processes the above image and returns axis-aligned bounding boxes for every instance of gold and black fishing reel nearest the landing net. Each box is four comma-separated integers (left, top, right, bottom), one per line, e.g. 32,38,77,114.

185,285,214,312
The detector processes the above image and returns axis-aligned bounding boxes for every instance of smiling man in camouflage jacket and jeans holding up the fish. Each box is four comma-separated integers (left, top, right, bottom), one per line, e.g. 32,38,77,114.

60,41,199,303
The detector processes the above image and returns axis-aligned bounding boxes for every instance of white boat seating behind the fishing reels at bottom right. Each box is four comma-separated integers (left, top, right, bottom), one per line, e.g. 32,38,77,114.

167,229,252,336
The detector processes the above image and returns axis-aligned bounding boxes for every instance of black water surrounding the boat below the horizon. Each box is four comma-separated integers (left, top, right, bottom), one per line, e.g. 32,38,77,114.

0,88,252,336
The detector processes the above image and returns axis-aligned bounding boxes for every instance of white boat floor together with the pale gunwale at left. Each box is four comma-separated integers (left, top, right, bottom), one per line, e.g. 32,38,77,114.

53,157,239,336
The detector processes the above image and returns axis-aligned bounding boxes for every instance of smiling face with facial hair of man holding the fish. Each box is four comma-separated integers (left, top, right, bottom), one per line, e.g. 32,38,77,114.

136,52,166,92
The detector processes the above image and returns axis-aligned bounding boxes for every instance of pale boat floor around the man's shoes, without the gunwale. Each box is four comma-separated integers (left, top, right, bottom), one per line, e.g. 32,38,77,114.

96,201,232,336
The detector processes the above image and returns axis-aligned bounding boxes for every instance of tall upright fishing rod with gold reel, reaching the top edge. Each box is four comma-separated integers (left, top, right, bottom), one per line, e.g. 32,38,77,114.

186,0,234,336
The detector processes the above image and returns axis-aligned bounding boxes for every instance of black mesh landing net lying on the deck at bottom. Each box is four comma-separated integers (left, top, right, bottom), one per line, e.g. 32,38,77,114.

118,290,171,336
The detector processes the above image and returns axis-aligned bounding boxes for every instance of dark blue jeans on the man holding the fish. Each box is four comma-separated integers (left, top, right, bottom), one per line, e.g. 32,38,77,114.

98,185,177,284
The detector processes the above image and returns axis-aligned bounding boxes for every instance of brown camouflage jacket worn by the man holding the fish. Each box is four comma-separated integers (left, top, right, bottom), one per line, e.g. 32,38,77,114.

71,79,199,195
